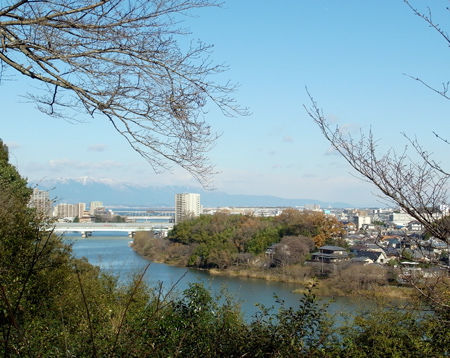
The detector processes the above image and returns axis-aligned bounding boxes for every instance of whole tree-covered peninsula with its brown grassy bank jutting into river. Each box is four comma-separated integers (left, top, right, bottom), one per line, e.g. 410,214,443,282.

133,209,411,298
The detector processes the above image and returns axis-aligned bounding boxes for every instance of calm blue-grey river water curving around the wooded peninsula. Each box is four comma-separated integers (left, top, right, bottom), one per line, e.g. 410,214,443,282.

65,233,375,319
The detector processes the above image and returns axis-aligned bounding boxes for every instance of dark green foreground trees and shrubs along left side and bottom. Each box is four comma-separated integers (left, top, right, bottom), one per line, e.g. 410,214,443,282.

0,144,450,357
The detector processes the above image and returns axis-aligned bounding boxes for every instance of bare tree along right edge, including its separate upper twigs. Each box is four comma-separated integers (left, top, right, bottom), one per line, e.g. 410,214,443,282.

304,0,450,314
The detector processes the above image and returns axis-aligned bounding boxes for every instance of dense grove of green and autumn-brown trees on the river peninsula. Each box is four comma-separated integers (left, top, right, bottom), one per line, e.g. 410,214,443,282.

160,209,343,268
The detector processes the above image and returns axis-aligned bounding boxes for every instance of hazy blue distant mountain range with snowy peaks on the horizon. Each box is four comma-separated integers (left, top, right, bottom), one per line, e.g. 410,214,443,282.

34,178,352,208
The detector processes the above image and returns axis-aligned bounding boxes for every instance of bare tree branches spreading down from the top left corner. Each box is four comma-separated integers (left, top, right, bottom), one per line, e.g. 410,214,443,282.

0,0,245,184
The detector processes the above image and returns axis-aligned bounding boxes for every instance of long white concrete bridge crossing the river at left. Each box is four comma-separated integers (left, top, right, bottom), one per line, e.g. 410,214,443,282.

54,222,173,237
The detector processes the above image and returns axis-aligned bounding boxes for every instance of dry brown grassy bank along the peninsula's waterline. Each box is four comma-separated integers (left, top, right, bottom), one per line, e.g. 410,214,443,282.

133,238,413,299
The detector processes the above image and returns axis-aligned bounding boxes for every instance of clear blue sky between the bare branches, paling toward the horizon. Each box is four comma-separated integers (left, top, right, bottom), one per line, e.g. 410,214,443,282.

0,0,450,205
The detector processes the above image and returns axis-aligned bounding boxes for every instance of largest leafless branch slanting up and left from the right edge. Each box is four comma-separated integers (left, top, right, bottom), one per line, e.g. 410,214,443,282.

304,93,450,243
